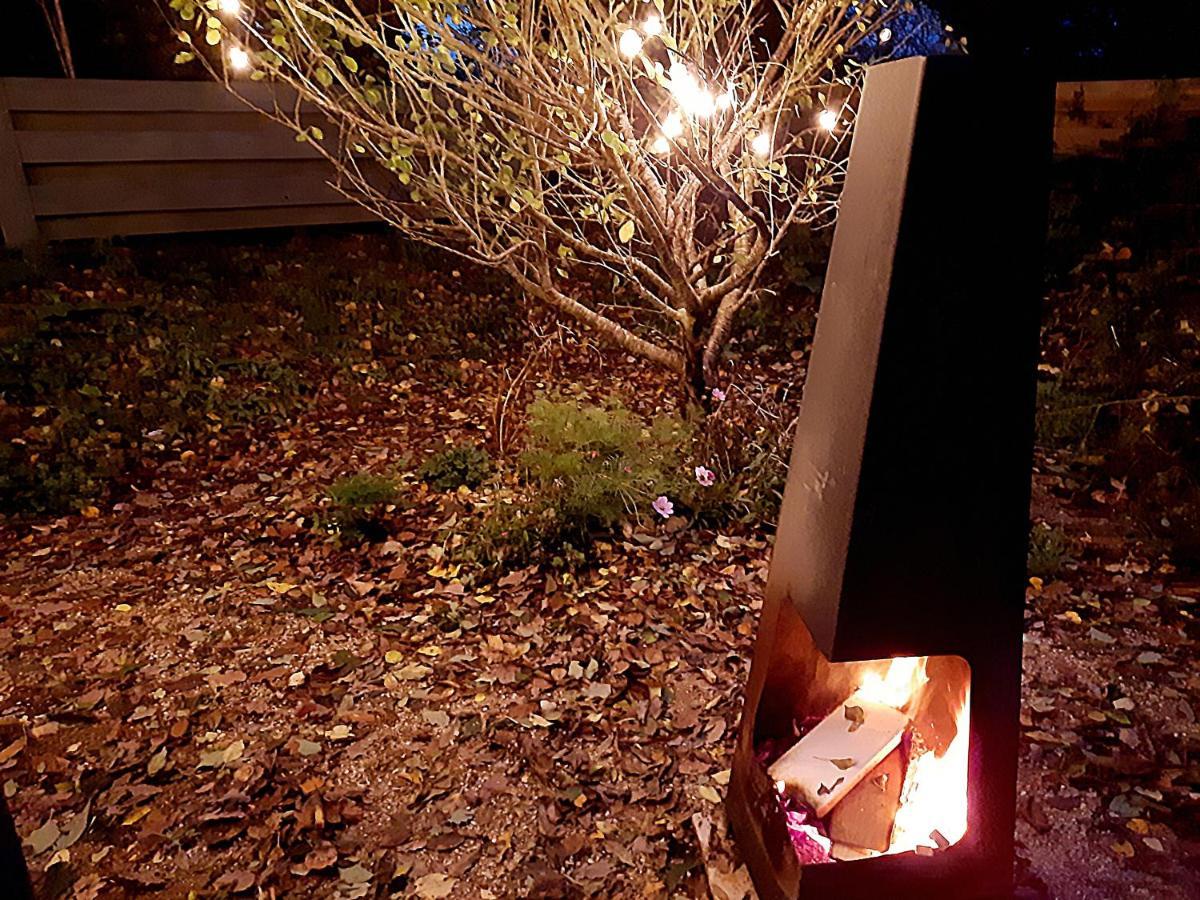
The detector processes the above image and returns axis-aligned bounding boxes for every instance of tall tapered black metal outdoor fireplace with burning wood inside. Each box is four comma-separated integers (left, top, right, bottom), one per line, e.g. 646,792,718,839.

728,58,1054,900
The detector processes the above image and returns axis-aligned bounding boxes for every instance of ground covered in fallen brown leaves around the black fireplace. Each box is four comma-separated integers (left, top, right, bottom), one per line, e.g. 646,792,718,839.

0,243,1200,900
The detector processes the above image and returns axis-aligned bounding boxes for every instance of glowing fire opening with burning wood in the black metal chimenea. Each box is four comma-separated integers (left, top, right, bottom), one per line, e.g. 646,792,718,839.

756,656,971,865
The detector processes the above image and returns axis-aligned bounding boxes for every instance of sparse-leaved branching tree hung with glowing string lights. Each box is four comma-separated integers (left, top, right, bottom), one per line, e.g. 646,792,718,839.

172,0,889,397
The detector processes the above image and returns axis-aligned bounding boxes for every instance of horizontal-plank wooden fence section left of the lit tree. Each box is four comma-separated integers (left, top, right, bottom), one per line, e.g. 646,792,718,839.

0,78,372,245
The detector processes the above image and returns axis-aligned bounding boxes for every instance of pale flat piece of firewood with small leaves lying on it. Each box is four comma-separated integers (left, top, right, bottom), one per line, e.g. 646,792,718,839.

768,694,908,825
